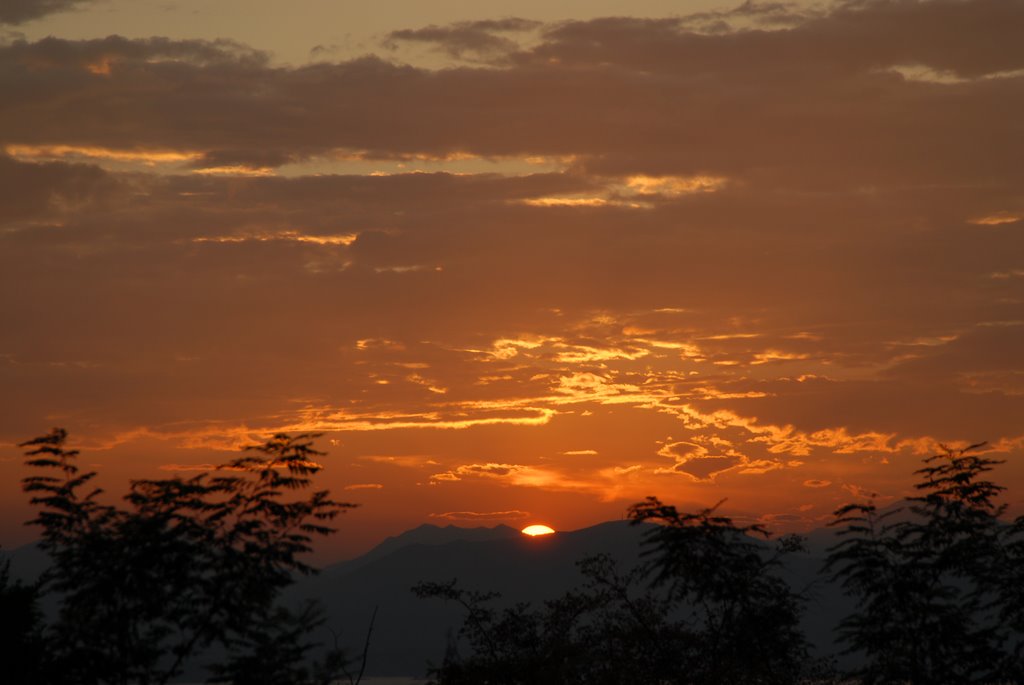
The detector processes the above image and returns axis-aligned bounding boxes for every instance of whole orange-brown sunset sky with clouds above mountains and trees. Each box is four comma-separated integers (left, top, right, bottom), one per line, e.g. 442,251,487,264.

0,0,1024,558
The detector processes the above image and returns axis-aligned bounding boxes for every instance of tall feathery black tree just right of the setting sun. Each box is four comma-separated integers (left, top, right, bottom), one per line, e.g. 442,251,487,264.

629,498,809,685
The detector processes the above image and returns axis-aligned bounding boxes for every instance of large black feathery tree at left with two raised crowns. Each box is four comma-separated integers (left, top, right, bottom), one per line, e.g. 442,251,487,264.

23,429,354,684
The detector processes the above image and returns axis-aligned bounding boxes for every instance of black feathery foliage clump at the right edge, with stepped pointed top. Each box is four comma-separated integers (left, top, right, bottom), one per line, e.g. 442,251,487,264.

826,443,1021,685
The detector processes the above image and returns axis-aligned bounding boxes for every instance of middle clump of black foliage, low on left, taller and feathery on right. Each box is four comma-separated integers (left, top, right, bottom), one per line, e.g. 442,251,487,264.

414,498,808,685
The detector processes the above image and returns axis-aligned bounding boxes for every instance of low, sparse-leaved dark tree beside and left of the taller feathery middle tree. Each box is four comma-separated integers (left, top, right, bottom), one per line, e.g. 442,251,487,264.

413,555,676,685
